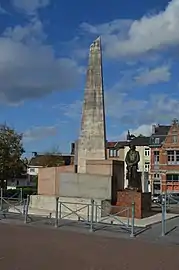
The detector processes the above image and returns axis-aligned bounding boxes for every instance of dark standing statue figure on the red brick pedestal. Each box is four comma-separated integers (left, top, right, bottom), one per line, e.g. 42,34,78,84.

125,144,141,191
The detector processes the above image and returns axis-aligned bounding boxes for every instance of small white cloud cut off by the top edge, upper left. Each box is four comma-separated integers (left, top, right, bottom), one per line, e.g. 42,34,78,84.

13,0,50,14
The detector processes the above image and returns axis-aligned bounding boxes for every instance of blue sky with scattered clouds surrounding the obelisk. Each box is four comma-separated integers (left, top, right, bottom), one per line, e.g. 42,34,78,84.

0,0,179,154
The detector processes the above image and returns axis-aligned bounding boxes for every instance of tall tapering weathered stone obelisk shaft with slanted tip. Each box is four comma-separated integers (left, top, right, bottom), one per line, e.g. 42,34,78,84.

77,37,106,173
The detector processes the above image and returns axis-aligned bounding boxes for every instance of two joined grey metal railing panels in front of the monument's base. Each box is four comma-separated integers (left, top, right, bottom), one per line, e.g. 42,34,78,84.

55,197,135,237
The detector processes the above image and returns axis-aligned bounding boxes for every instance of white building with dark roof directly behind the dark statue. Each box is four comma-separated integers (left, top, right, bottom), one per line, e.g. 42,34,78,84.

124,136,150,192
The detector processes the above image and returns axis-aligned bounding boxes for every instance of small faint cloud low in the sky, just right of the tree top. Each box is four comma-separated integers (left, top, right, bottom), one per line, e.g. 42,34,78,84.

23,126,57,142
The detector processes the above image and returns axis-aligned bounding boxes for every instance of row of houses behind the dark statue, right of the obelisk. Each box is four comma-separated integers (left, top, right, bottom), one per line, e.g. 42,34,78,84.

107,119,179,194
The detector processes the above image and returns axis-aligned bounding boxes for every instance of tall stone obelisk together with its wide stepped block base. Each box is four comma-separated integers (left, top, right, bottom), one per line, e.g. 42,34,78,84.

30,38,124,219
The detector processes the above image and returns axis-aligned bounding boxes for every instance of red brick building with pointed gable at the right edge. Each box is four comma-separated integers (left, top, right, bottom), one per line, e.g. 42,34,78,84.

150,119,179,194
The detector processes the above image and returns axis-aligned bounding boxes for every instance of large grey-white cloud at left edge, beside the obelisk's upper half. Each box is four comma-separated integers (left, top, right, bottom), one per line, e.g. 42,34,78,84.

0,18,82,103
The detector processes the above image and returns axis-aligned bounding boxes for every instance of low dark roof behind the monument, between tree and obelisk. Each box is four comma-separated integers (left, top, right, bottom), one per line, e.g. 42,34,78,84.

29,154,71,167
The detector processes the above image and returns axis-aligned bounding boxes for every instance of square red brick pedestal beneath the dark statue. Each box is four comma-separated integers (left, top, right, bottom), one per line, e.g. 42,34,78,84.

114,190,151,219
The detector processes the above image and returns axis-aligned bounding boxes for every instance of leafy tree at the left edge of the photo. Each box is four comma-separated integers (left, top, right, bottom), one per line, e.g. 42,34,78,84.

0,124,25,187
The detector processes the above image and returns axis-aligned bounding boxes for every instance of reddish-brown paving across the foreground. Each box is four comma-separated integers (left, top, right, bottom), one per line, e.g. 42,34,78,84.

0,224,179,270
